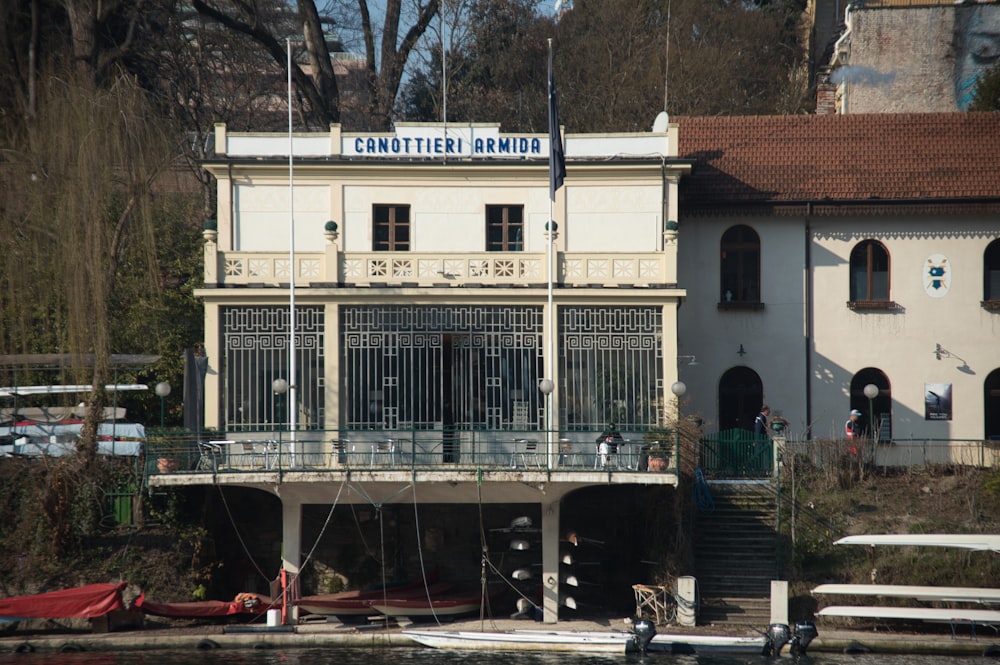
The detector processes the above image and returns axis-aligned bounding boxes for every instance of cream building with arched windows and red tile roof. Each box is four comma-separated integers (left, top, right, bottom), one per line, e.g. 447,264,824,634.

678,113,1000,452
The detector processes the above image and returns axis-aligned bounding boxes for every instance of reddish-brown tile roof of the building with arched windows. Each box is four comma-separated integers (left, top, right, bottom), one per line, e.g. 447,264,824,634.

671,112,1000,208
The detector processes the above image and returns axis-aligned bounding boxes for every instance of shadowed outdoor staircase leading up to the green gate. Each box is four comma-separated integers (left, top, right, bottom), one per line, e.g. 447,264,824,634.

694,481,778,630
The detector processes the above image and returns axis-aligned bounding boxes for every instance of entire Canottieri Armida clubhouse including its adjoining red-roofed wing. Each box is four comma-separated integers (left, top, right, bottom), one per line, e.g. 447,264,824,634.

151,114,1000,621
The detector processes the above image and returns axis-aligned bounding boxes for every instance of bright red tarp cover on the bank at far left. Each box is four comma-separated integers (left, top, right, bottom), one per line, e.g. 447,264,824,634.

0,582,125,619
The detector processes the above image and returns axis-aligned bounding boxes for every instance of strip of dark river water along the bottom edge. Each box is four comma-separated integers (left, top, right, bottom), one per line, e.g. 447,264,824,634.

0,638,976,665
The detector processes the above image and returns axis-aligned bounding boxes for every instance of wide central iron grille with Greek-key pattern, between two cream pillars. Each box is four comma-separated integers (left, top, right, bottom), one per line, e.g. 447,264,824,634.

341,306,544,431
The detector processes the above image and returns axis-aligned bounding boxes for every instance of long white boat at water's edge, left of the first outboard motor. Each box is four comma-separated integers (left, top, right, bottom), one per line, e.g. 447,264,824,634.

403,630,634,654
